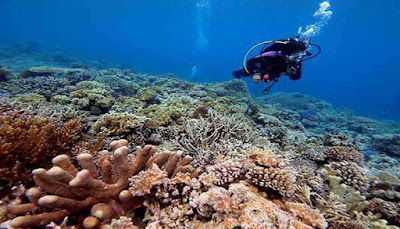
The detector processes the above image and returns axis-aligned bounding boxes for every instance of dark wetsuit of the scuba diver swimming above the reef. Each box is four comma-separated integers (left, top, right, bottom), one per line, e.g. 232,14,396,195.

232,38,307,81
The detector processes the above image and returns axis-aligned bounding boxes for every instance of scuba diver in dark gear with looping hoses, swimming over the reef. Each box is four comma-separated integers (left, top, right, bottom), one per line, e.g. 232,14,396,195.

232,36,321,93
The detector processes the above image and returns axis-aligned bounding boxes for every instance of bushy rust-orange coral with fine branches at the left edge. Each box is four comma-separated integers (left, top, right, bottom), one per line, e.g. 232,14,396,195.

0,115,82,197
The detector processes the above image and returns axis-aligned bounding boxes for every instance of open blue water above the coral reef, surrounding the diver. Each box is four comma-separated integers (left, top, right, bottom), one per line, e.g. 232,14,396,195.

0,0,400,120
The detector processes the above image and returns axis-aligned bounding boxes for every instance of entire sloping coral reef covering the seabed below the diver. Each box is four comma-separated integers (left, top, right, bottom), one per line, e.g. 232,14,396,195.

0,47,400,228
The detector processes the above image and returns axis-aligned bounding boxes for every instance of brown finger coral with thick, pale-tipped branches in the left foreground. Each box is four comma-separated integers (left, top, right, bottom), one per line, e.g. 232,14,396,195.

2,141,155,228
